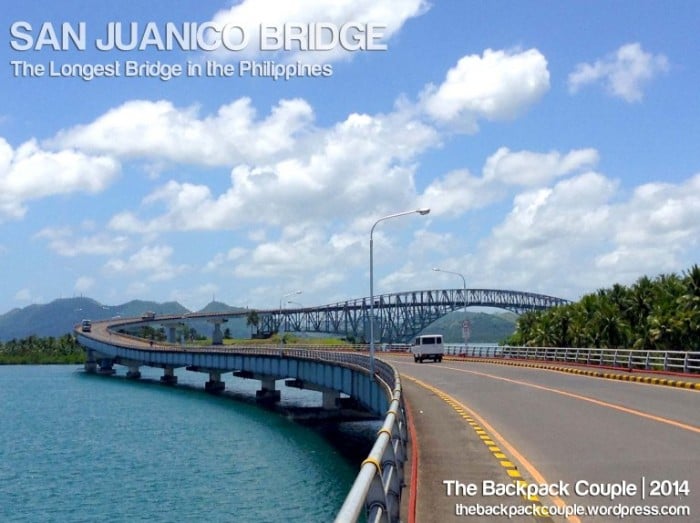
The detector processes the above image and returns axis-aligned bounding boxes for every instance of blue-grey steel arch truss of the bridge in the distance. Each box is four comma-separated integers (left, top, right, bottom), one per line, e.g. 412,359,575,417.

259,289,568,343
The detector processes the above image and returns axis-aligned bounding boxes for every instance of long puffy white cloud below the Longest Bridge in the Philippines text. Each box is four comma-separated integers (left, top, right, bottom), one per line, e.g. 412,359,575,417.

48,98,313,166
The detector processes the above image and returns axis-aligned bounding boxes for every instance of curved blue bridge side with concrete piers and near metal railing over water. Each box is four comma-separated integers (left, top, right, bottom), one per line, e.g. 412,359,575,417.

75,318,409,523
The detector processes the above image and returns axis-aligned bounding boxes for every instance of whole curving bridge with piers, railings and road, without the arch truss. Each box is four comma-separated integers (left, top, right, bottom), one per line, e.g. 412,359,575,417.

77,292,700,522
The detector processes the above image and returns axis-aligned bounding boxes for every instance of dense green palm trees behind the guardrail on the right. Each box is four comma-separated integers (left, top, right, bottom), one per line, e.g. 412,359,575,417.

505,265,700,351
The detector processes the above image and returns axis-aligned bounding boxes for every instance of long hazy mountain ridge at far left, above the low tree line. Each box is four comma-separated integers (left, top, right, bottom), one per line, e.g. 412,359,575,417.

0,298,190,341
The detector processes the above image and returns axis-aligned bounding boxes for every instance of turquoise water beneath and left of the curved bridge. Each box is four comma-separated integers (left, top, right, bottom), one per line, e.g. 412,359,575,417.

0,366,366,523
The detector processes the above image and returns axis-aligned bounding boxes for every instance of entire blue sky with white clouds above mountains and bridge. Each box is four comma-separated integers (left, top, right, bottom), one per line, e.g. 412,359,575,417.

0,0,700,313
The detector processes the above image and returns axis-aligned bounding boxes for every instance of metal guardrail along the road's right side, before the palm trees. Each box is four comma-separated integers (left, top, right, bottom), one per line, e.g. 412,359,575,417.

445,345,700,374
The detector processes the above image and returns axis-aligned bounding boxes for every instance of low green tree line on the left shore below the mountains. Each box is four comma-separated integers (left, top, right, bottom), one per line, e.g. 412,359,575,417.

0,334,85,365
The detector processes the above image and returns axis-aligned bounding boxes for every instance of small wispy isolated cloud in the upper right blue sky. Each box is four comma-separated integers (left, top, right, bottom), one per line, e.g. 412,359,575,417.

568,43,669,102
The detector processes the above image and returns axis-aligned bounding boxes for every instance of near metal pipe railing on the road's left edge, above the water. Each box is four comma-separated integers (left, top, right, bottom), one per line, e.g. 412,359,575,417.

335,361,408,523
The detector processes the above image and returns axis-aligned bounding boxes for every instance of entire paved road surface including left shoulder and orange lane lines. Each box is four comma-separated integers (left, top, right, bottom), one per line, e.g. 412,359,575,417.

383,354,700,522
